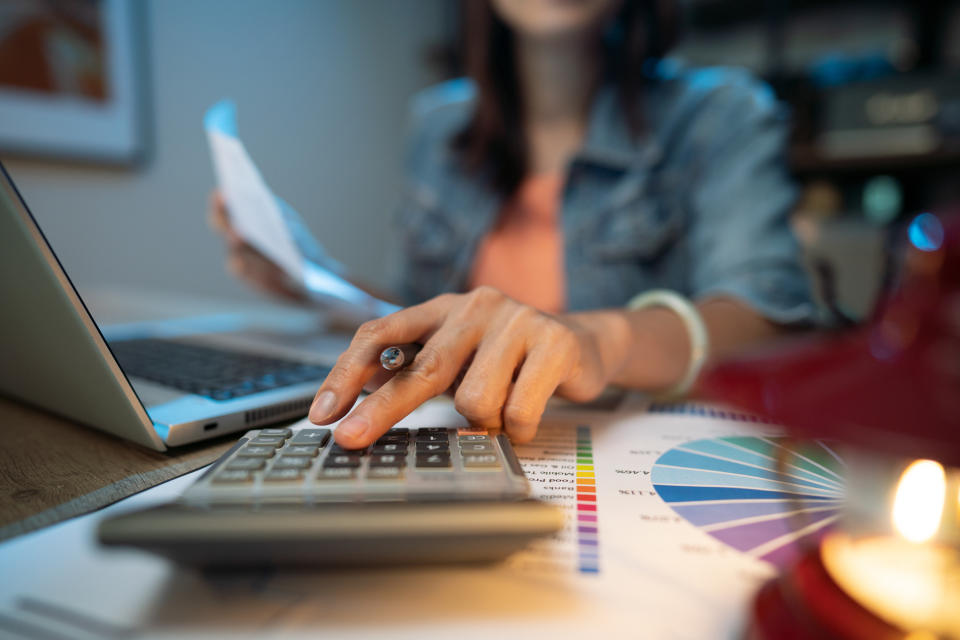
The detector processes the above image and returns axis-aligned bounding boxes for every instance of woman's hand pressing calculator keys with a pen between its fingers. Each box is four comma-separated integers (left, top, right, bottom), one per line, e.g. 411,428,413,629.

310,287,611,448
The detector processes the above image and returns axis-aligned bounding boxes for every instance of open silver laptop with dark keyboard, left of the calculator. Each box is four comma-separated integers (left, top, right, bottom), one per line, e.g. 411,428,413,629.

0,164,332,451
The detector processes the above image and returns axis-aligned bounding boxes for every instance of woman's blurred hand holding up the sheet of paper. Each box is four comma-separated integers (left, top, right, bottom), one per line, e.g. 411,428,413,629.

208,191,307,302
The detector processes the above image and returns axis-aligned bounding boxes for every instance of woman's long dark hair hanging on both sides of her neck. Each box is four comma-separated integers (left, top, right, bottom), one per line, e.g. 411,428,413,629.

453,0,679,196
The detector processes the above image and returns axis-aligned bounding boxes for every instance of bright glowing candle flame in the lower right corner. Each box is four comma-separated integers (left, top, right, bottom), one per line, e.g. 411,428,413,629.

893,460,947,542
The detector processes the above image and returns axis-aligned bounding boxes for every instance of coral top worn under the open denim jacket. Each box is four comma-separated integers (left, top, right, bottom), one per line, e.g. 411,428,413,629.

469,173,566,313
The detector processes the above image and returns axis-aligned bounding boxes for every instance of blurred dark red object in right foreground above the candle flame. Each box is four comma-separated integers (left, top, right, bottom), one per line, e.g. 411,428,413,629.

701,214,960,466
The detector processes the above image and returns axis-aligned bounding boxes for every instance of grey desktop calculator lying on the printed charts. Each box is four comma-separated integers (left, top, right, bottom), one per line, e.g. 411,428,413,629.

98,427,564,567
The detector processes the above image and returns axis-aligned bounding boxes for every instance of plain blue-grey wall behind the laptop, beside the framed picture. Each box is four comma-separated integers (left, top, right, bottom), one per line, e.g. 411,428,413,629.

0,0,449,298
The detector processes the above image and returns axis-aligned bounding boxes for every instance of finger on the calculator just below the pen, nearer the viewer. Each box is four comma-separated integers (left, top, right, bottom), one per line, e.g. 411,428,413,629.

335,322,481,448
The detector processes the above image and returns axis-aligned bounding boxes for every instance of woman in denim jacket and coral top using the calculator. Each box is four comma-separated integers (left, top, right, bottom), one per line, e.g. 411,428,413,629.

212,0,814,448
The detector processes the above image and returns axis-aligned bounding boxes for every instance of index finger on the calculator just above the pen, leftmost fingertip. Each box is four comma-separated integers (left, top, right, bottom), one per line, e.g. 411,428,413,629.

310,296,451,424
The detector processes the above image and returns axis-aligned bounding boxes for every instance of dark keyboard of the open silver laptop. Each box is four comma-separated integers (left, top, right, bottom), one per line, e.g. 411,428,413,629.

110,338,330,401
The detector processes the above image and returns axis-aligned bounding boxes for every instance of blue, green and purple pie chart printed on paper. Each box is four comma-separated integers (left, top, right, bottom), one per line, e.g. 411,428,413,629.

651,436,844,567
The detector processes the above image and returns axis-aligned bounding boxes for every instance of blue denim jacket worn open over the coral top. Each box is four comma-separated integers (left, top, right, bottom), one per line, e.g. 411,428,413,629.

397,64,815,324
